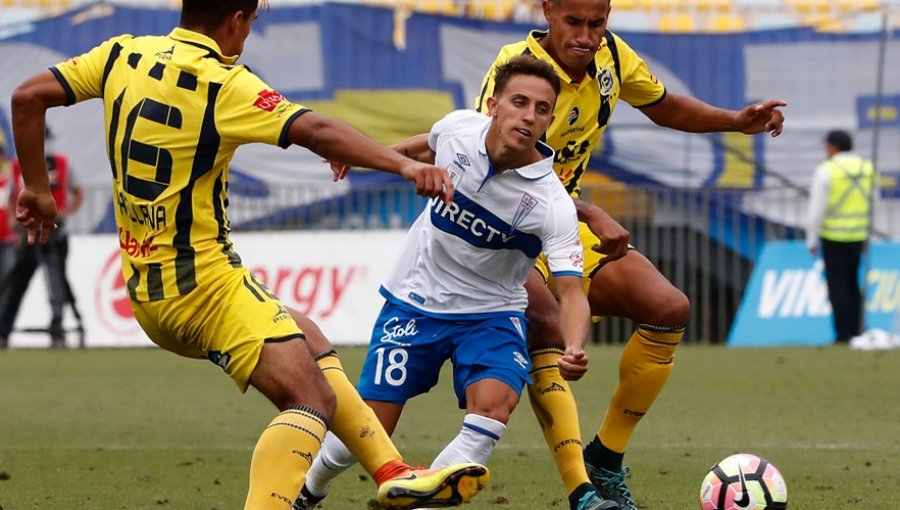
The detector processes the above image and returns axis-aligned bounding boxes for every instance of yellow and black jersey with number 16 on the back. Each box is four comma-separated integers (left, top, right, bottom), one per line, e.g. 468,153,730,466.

51,28,308,301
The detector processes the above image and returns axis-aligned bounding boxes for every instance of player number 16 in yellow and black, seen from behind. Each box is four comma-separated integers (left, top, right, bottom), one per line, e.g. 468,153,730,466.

12,0,487,510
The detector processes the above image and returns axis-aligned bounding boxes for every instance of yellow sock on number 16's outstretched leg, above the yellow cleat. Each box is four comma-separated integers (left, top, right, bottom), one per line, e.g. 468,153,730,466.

316,351,403,474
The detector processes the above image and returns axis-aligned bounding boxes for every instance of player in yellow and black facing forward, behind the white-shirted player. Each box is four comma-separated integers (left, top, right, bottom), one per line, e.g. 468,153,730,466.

475,0,786,510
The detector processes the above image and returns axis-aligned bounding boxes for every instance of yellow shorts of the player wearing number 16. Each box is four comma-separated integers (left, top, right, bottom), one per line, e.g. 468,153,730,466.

131,267,303,392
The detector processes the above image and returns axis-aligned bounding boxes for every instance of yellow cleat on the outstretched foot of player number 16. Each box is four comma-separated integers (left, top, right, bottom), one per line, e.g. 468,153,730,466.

378,462,491,510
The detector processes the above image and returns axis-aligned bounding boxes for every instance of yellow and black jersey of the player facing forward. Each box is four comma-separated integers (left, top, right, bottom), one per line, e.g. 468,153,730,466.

475,30,666,196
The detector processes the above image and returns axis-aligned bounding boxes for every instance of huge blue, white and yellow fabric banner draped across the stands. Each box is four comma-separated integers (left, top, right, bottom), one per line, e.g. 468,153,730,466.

0,2,900,233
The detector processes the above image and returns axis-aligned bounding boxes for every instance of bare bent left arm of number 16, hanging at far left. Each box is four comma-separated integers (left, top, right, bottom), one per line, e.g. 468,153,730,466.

12,71,67,244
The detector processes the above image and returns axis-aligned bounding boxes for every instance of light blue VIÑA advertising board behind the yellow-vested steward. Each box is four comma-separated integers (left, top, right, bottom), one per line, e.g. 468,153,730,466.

728,241,900,347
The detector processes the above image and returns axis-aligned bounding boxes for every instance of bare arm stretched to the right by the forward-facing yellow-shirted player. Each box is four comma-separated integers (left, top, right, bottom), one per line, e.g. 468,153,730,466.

641,94,787,136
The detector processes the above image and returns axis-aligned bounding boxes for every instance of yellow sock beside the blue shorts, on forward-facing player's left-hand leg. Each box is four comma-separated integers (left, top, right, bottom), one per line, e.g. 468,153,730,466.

528,345,591,494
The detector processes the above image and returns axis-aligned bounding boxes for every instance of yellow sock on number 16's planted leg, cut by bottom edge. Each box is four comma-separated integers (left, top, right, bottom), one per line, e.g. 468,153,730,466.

244,407,327,510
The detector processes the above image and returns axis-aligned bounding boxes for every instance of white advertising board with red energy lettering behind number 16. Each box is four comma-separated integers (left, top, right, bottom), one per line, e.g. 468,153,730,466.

9,230,406,347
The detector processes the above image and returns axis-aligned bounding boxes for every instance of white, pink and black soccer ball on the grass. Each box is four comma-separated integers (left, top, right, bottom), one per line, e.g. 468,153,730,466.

700,453,787,510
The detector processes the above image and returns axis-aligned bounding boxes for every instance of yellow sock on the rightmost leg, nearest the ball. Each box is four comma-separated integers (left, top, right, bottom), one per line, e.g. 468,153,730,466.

597,324,684,453
